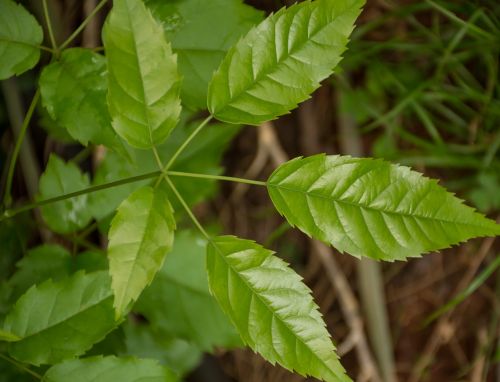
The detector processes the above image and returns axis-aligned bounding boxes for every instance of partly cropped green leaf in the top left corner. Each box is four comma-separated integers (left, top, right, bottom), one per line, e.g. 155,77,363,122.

0,0,43,80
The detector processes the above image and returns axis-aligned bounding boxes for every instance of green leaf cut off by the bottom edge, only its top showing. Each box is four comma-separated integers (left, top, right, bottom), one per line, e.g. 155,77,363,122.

42,356,177,382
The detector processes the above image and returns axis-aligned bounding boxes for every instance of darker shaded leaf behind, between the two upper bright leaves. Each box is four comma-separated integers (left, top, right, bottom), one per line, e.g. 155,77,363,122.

146,0,263,109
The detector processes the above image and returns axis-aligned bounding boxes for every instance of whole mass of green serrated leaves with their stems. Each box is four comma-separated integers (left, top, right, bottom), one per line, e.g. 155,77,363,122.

0,0,500,382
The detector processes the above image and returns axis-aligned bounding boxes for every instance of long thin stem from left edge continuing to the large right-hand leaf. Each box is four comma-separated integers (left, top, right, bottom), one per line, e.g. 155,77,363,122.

0,170,267,221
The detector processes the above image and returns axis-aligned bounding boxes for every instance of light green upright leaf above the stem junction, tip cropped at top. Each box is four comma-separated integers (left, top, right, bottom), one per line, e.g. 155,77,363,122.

103,0,181,149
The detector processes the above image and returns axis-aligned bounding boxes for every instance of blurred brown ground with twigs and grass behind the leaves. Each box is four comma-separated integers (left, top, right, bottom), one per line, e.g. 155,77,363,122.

0,0,500,382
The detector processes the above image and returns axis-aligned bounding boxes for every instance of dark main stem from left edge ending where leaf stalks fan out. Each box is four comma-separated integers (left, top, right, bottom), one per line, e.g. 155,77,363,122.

0,171,162,221
